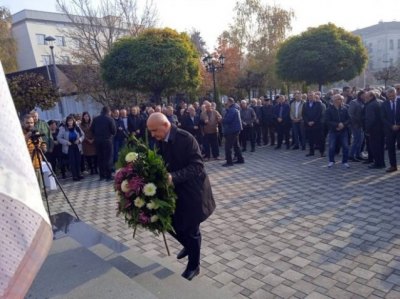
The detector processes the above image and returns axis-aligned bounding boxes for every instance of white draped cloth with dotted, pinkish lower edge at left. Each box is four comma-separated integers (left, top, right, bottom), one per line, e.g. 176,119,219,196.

0,64,52,298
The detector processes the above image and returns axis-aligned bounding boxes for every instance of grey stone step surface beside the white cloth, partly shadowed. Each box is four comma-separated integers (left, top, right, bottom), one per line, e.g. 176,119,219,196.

26,236,157,299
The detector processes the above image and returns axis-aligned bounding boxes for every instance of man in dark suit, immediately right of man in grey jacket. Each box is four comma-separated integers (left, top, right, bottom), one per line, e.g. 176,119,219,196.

303,91,325,157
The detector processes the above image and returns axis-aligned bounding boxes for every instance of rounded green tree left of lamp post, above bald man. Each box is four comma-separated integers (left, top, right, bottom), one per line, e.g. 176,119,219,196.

101,28,200,103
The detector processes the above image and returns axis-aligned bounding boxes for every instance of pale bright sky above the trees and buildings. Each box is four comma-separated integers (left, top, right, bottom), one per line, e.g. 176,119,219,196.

0,0,400,50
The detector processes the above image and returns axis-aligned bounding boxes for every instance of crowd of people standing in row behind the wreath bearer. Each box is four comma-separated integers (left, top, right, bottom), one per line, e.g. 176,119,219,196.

24,84,400,181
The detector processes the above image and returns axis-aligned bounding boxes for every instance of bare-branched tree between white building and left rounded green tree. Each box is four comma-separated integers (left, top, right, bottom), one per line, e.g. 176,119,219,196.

57,0,157,64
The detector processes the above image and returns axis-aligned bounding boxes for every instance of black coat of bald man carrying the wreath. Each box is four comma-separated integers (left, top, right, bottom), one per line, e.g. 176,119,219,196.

158,125,215,230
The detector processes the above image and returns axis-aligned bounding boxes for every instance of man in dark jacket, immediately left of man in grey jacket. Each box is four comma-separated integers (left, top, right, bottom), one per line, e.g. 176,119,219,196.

274,95,291,149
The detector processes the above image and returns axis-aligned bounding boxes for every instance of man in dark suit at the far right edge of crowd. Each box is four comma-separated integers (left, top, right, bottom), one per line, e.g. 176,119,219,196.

382,87,400,172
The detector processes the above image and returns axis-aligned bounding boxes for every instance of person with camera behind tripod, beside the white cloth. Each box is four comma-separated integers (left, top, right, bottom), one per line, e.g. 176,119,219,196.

23,114,47,188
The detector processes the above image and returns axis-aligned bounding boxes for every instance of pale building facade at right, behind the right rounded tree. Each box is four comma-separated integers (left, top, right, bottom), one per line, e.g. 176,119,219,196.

353,21,400,72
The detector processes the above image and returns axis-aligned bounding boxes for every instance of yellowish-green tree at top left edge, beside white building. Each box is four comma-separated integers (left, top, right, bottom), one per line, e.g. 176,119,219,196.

0,6,18,73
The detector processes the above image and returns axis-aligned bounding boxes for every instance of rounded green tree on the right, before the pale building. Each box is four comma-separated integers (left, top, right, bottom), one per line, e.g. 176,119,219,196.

276,23,367,90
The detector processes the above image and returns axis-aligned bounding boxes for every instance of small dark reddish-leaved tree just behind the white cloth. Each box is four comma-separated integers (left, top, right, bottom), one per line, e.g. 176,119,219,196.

7,73,58,114
